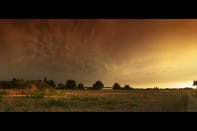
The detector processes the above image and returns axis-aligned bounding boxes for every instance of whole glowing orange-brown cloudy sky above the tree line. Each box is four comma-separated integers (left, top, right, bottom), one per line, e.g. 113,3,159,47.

0,19,197,88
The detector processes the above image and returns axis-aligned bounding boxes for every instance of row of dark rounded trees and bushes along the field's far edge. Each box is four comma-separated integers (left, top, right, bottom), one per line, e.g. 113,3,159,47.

0,77,133,90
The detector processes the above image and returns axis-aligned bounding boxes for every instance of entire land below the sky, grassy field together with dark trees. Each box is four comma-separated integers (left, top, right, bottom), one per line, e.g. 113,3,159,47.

0,77,194,112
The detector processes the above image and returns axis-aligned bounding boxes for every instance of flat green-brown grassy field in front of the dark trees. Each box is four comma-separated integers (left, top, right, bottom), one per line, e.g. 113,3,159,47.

0,89,192,112
